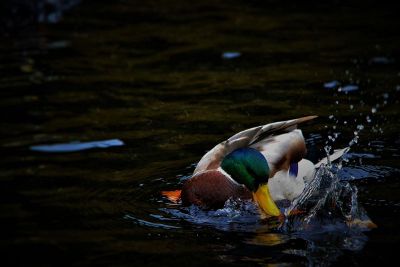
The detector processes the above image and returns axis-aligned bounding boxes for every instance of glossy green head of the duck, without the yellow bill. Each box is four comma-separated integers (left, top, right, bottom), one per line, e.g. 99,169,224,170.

221,147,269,192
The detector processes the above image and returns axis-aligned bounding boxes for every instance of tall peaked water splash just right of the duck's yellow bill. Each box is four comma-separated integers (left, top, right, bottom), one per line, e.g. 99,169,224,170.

282,165,374,231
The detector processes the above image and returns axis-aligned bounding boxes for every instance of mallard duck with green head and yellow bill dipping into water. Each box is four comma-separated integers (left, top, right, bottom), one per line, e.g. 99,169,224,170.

162,116,347,217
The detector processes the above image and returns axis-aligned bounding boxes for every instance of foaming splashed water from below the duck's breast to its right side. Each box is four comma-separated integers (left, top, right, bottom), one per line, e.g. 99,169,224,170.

160,162,374,233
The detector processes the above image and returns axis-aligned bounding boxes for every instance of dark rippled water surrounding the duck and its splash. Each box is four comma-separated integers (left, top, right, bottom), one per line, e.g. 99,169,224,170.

0,0,400,266
